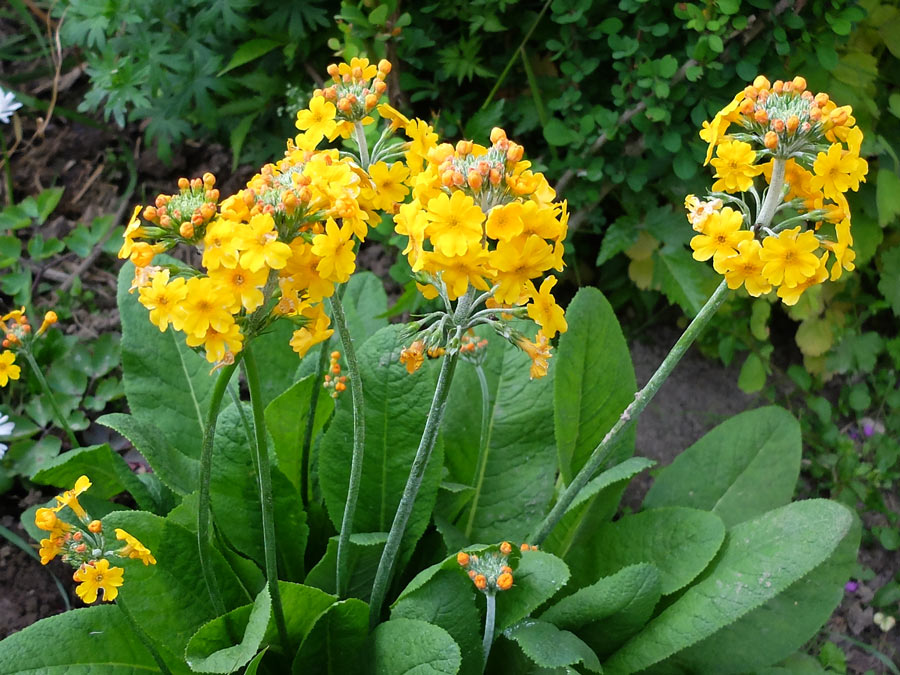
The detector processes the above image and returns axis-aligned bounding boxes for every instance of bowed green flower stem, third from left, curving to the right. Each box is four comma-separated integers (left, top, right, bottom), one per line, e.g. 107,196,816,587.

331,294,366,597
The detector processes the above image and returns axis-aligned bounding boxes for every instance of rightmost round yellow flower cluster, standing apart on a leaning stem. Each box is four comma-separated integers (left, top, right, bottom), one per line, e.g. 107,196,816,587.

685,75,868,305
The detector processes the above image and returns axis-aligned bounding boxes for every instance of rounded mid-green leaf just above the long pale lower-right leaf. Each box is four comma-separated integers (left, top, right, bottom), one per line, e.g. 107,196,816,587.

572,507,725,595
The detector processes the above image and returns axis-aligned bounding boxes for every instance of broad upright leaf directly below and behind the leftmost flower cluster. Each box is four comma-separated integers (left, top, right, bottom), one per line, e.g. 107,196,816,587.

118,258,215,458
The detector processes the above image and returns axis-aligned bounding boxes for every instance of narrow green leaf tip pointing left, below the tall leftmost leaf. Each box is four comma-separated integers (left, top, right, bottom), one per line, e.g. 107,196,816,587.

97,413,200,495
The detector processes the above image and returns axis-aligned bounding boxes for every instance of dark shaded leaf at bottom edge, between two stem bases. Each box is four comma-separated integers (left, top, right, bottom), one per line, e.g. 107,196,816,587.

292,598,369,675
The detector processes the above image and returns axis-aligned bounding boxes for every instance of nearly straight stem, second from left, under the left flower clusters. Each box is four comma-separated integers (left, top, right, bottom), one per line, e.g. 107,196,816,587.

243,345,288,650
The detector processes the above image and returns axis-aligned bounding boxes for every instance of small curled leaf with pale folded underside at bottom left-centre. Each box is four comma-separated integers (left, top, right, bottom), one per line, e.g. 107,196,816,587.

185,586,272,673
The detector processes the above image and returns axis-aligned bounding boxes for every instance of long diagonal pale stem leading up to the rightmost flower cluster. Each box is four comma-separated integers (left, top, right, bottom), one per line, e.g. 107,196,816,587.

530,281,728,545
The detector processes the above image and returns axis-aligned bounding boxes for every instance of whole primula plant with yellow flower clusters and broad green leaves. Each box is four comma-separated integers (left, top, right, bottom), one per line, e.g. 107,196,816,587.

0,58,865,673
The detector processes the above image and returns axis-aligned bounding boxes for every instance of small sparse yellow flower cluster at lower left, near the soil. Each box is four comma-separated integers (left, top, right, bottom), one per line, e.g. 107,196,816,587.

34,476,156,604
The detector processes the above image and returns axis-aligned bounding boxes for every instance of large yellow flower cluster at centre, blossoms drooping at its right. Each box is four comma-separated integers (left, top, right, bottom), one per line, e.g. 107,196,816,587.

394,127,568,377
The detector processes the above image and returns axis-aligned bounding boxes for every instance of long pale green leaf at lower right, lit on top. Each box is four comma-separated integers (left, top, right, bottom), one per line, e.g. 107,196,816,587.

604,499,855,673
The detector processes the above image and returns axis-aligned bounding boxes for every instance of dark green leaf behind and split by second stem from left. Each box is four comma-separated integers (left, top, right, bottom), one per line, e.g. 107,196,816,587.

210,404,309,581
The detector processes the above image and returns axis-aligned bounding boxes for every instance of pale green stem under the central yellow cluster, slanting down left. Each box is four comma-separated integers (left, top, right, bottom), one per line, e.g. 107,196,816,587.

369,338,460,628
